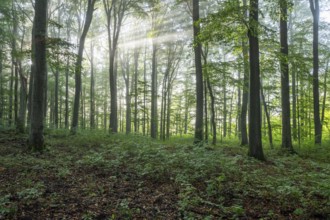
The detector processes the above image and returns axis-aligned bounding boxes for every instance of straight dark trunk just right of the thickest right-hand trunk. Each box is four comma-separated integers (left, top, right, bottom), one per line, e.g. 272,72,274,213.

280,0,293,152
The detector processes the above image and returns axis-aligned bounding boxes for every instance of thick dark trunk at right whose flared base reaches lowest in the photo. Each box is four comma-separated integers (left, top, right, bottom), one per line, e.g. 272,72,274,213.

248,0,265,160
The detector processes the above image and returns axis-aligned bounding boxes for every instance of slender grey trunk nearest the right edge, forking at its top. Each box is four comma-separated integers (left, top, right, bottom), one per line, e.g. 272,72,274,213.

309,0,322,144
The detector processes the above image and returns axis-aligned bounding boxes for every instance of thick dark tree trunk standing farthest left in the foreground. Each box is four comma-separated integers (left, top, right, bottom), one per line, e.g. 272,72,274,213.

29,0,48,152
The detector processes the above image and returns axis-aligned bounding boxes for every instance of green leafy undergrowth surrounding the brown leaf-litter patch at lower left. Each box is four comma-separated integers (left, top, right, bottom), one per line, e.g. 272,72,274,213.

0,131,330,219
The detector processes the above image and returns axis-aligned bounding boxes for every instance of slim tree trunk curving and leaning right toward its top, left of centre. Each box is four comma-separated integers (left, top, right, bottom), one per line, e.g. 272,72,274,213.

71,0,96,134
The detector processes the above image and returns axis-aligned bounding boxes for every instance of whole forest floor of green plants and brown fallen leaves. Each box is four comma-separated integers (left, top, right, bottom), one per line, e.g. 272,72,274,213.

0,131,330,220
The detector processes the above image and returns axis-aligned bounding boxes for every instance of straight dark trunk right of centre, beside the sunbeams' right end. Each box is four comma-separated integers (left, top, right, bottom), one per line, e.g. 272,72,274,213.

193,0,204,144
